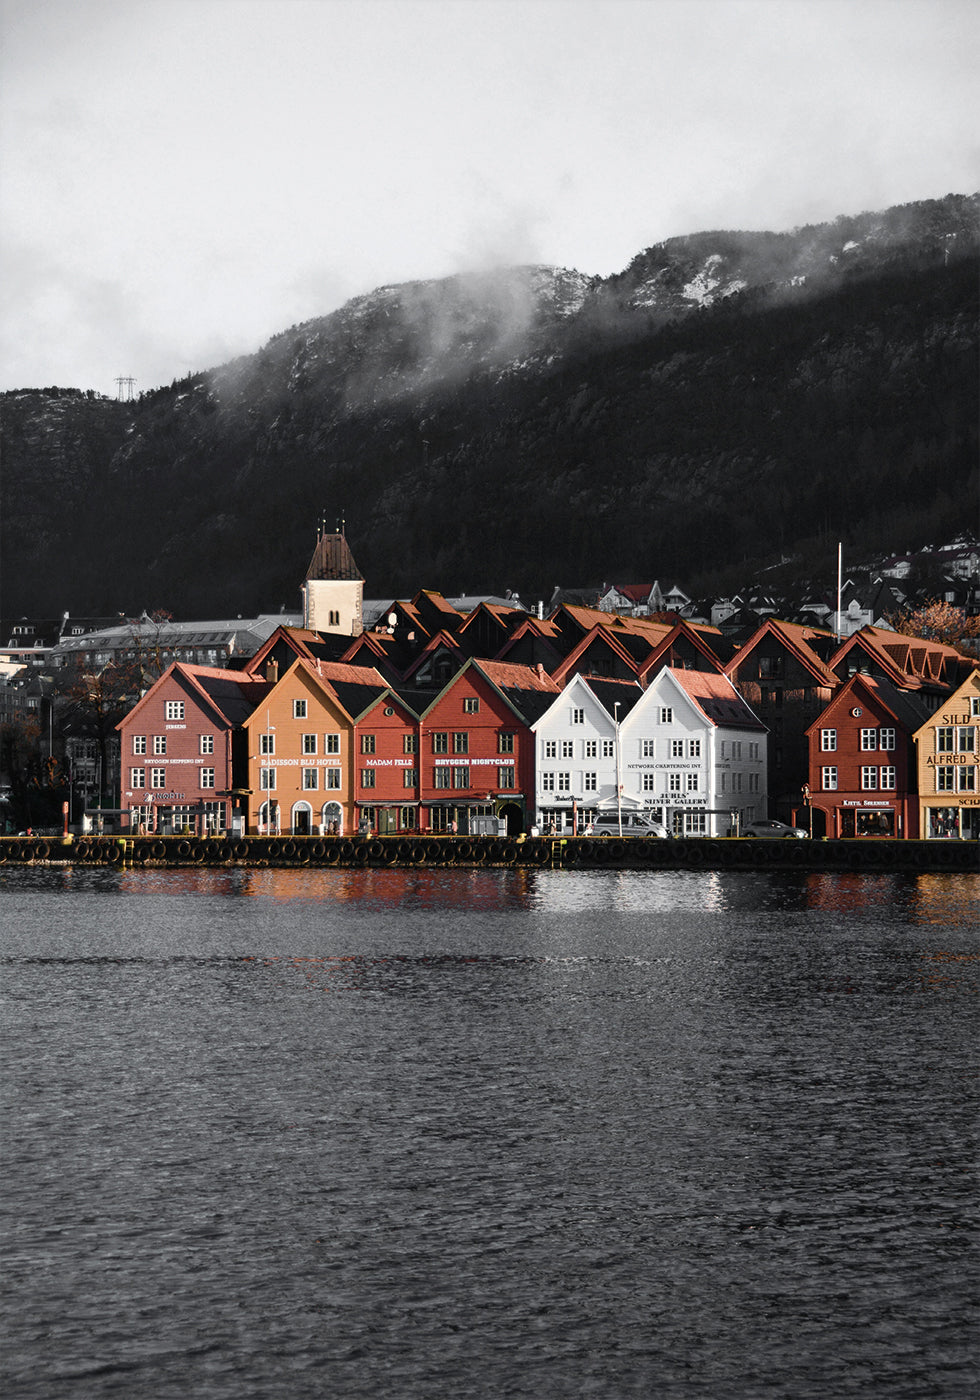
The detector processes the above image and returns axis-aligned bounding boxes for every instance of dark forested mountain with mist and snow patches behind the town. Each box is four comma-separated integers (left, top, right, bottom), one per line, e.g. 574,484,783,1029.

0,195,980,616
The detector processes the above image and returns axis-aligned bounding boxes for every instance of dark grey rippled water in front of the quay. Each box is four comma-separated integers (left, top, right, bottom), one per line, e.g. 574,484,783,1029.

0,869,980,1400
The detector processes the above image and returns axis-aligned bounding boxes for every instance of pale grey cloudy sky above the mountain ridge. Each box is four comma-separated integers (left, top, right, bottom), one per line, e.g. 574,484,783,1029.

0,0,980,396
